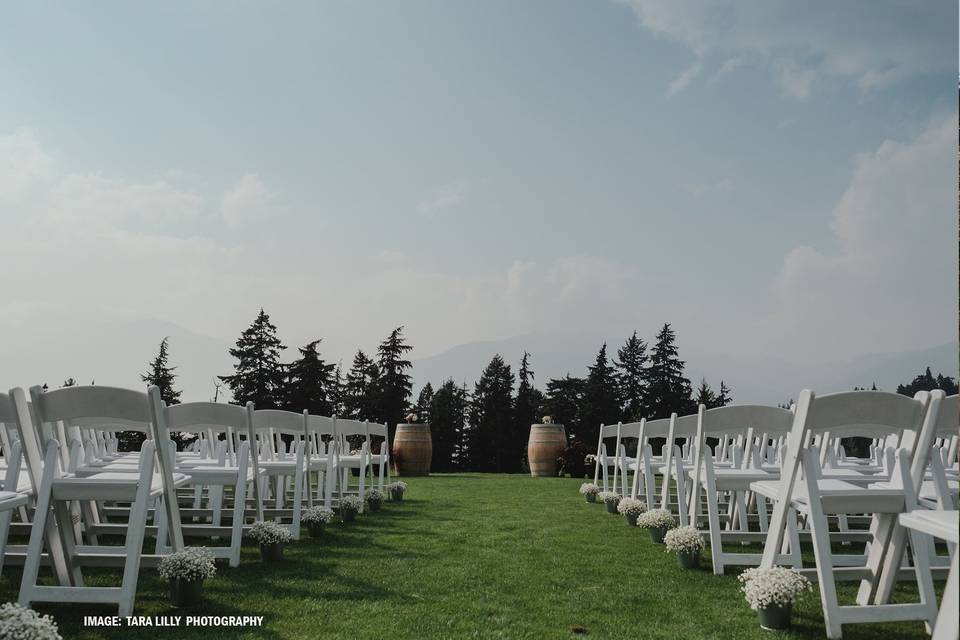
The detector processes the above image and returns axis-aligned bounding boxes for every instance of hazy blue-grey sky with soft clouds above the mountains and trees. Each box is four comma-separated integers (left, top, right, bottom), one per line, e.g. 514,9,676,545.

0,0,958,384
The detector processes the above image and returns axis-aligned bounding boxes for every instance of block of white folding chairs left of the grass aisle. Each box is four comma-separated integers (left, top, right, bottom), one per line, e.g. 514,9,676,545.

0,386,390,616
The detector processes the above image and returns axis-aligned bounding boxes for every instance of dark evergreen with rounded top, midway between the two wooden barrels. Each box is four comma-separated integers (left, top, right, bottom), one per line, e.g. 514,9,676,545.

467,354,514,472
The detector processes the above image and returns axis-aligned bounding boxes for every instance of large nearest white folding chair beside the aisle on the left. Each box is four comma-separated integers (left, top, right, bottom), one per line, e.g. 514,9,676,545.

11,386,187,616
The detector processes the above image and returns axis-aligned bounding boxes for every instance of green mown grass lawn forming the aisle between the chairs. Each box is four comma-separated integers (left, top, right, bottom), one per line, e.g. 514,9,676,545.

0,474,944,639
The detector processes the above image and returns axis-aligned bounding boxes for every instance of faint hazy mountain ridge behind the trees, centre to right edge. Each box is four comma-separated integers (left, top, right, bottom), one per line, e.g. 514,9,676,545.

413,333,957,404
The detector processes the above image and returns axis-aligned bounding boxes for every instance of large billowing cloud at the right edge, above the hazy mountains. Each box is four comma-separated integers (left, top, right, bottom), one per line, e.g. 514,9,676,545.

769,113,958,357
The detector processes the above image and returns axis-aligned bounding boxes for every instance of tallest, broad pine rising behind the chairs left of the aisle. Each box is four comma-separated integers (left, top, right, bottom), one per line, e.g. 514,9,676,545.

220,308,286,409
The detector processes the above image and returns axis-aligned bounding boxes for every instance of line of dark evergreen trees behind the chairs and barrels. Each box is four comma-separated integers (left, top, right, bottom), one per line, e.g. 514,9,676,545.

133,309,956,473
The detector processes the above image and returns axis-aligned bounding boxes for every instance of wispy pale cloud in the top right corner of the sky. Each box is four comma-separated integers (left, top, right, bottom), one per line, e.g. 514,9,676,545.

620,0,957,99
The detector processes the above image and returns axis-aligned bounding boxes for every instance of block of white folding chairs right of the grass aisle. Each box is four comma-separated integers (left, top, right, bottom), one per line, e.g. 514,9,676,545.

594,390,960,639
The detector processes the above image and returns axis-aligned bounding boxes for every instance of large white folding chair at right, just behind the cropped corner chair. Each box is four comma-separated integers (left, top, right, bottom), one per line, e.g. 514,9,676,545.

751,390,943,638
